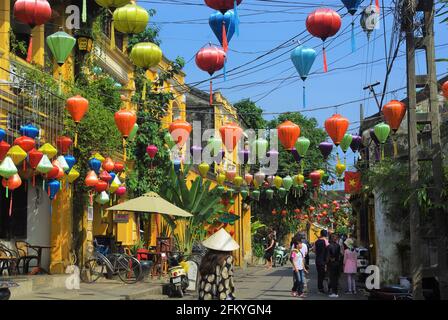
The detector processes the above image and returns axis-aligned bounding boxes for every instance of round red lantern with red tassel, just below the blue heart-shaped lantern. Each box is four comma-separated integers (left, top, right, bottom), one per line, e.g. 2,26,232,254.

196,45,226,105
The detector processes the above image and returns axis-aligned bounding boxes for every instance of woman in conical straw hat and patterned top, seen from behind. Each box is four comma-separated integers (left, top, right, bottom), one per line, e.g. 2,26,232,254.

199,228,240,300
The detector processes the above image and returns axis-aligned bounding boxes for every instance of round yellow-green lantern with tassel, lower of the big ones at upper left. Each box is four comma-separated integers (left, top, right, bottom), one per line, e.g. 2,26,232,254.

129,42,163,100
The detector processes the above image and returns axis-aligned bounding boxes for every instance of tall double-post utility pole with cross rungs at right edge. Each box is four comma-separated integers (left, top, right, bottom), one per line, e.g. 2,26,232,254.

402,0,448,299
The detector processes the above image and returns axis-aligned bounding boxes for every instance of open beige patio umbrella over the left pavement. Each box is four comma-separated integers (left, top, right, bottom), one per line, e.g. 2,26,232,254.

106,192,193,217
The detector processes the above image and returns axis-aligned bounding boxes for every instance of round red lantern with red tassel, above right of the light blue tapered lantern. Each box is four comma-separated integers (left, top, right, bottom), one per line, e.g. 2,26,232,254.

306,8,342,72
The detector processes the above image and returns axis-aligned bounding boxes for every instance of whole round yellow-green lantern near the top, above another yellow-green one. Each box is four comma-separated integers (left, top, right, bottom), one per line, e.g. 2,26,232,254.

114,3,149,34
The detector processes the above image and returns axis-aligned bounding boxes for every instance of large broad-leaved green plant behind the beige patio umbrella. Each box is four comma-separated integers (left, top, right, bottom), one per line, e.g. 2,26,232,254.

160,166,223,254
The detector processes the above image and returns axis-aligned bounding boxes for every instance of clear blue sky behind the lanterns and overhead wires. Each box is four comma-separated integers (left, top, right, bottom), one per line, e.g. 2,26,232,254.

138,0,448,186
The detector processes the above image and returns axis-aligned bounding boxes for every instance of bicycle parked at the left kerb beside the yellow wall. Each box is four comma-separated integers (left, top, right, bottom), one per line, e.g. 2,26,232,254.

81,251,143,284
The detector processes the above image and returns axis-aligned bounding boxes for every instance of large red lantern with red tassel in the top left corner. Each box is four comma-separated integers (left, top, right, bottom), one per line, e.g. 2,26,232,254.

13,0,52,62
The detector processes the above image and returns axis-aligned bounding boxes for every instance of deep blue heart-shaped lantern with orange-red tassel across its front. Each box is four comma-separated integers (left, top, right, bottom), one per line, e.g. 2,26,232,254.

208,10,236,52
